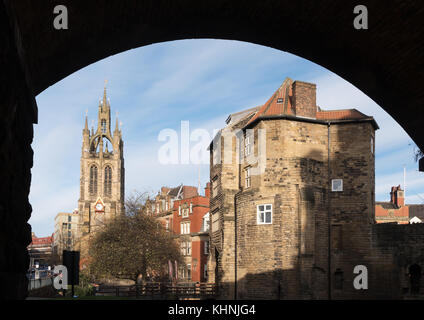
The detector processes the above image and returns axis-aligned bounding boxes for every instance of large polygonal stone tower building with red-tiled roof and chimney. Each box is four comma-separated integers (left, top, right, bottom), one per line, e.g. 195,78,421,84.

209,78,378,299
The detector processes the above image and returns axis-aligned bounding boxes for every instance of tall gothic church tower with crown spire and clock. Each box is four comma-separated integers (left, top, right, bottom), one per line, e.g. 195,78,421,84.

78,86,125,237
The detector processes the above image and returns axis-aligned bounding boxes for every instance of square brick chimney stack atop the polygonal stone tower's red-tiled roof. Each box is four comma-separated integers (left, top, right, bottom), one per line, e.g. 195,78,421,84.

292,81,317,119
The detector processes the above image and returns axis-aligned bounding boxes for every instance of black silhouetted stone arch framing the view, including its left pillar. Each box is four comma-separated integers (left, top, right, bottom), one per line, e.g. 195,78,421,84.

0,0,424,298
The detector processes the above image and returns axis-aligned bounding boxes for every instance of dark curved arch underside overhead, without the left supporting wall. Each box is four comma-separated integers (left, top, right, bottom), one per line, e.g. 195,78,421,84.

6,0,424,147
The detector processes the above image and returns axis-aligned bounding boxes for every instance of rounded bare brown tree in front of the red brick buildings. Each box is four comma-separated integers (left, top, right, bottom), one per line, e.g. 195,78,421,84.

90,190,182,280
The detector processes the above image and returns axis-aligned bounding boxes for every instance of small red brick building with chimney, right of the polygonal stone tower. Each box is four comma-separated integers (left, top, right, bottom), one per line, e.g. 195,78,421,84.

375,185,410,224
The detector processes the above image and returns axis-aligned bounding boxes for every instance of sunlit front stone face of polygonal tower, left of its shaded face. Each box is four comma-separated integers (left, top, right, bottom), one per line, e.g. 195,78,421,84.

237,120,327,299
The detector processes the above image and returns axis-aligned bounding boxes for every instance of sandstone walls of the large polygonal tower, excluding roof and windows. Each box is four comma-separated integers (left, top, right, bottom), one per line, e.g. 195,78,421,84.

211,115,380,299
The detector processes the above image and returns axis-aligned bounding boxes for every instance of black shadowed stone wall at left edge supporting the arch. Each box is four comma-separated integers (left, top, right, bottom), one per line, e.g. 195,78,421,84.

0,1,37,299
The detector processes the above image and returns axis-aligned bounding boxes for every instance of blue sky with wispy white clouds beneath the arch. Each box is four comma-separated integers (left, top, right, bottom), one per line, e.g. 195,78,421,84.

30,40,424,236
